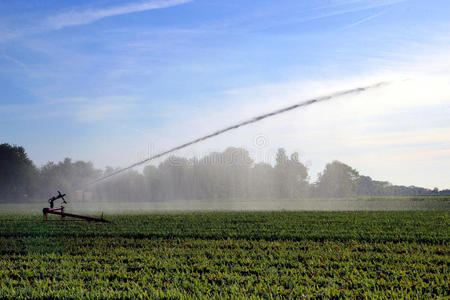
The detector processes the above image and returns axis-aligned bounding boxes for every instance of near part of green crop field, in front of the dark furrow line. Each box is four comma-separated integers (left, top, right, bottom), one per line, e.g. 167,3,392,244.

0,238,449,298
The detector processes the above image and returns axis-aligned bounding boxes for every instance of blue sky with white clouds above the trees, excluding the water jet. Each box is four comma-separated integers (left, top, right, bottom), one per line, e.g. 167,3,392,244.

0,0,450,189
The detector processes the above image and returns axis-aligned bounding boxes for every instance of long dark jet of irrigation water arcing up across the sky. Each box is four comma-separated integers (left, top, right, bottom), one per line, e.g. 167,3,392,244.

87,81,390,186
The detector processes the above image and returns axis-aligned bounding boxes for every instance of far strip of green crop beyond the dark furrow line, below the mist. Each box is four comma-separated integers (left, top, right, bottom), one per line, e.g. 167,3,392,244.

0,212,450,244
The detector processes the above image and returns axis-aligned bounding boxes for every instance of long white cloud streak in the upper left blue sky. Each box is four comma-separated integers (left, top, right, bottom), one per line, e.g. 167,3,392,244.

47,0,192,29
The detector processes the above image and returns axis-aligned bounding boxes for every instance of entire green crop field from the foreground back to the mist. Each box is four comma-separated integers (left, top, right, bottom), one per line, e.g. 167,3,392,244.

0,211,450,299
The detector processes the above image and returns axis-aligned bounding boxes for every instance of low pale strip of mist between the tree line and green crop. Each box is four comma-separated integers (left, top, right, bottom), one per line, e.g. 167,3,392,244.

5,197,450,214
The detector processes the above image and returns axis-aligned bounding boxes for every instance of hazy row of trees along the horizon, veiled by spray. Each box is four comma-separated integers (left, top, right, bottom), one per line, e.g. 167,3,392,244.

0,143,450,202
